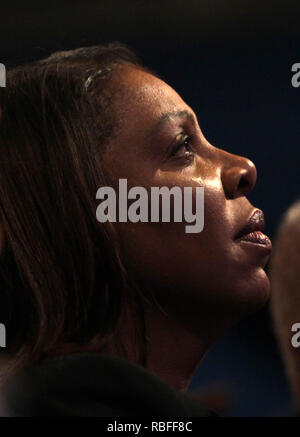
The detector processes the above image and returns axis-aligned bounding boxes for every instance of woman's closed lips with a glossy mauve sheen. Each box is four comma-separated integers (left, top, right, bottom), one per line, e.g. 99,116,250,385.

235,209,272,252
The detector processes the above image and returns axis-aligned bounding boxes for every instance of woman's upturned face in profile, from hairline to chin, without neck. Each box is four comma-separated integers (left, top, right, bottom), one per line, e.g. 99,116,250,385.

104,68,271,317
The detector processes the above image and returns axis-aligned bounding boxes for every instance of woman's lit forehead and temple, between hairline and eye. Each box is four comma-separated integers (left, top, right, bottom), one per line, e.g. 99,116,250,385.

103,67,196,182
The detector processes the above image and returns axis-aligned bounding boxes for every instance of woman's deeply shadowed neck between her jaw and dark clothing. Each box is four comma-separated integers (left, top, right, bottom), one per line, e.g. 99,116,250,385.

104,296,233,392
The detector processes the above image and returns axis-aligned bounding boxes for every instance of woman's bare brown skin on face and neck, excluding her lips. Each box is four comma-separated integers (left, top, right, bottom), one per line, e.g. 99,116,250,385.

104,67,270,391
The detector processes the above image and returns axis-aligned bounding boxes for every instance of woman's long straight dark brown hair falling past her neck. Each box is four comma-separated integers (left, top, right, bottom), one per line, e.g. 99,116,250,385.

0,43,149,378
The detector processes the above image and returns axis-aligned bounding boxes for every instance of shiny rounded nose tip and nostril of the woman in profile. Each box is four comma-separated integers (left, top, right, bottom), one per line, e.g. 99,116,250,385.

221,152,257,199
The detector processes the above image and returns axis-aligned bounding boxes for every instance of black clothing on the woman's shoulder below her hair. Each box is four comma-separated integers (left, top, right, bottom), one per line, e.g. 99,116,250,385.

1,353,214,417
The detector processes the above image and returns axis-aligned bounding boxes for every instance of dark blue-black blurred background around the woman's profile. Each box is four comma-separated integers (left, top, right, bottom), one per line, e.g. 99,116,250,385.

0,0,300,416
